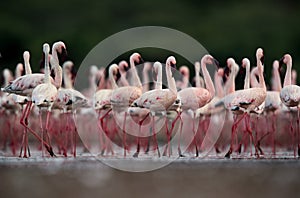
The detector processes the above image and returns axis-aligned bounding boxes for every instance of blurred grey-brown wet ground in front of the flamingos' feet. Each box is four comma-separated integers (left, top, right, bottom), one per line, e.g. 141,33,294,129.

0,156,300,198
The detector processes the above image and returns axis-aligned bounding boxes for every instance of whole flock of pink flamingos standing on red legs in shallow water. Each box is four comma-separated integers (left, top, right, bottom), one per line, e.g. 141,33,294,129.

0,41,300,158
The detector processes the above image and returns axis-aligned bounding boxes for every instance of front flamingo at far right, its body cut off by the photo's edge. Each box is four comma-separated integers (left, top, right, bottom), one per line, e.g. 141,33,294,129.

279,54,300,156
